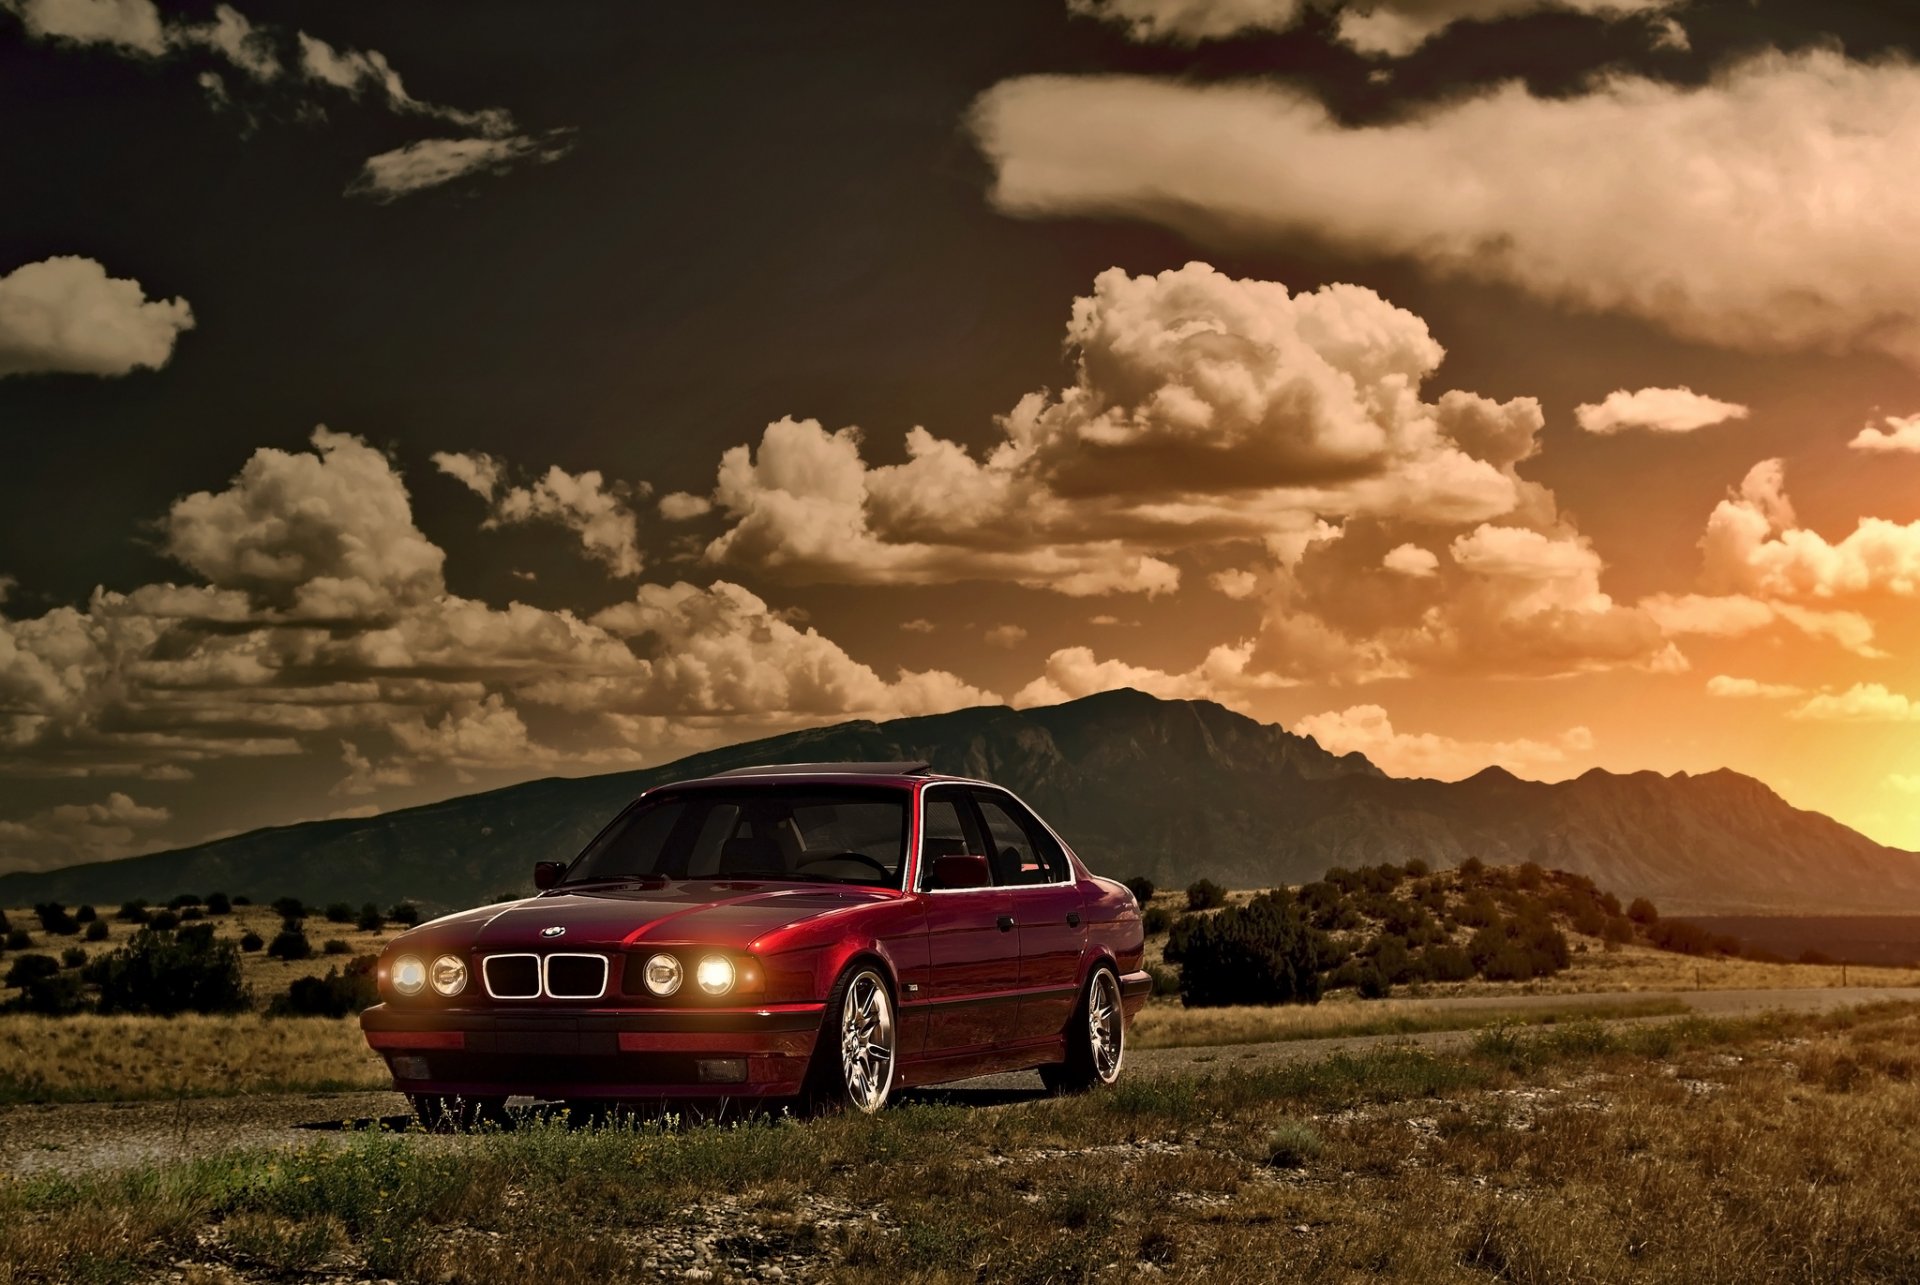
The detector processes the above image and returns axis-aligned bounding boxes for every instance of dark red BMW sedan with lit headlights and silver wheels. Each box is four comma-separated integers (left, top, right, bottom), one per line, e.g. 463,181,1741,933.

361,763,1152,1124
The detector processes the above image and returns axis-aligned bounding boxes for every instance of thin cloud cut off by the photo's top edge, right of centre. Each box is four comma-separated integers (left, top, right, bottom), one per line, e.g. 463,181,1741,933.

1068,0,1686,58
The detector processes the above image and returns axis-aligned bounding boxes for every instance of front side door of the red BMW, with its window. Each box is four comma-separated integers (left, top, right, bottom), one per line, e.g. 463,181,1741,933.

920,786,1020,1056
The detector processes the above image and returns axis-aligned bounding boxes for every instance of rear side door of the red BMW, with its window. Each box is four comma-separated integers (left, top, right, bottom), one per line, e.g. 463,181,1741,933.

973,789,1087,1039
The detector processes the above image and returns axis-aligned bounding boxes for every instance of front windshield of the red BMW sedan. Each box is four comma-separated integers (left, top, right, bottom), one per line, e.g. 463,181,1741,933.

563,786,910,887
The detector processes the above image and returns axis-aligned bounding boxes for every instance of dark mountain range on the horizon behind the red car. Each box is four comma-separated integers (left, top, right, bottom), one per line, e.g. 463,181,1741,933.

0,691,1920,912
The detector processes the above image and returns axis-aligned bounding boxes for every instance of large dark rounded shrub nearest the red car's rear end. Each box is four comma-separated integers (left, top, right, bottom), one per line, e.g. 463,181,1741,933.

1181,893,1321,1008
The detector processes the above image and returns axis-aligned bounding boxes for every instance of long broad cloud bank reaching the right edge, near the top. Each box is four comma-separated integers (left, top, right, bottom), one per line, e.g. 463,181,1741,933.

972,48,1920,365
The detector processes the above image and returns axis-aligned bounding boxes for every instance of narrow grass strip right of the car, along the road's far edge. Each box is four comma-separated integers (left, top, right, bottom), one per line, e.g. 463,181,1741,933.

1127,991,1688,1049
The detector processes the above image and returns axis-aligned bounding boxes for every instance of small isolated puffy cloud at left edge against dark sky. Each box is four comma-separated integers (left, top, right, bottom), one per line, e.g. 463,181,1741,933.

0,255,194,378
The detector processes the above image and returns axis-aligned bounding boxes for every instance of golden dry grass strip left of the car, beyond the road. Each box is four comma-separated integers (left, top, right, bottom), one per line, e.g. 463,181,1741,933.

0,1014,392,1103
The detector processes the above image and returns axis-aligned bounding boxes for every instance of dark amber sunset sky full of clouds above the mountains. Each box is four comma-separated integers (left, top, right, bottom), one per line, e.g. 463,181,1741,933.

0,0,1920,870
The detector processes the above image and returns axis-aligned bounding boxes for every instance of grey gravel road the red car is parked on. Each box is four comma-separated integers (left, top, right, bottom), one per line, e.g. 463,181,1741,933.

0,987,1920,1176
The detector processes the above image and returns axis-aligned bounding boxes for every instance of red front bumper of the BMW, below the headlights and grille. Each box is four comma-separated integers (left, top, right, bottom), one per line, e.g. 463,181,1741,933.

361,1003,826,1099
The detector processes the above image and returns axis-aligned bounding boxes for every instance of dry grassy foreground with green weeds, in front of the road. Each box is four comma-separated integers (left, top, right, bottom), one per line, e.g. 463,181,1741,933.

0,1005,1920,1285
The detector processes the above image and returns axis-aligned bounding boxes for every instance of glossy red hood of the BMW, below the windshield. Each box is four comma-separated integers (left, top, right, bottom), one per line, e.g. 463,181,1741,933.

434,880,900,951
